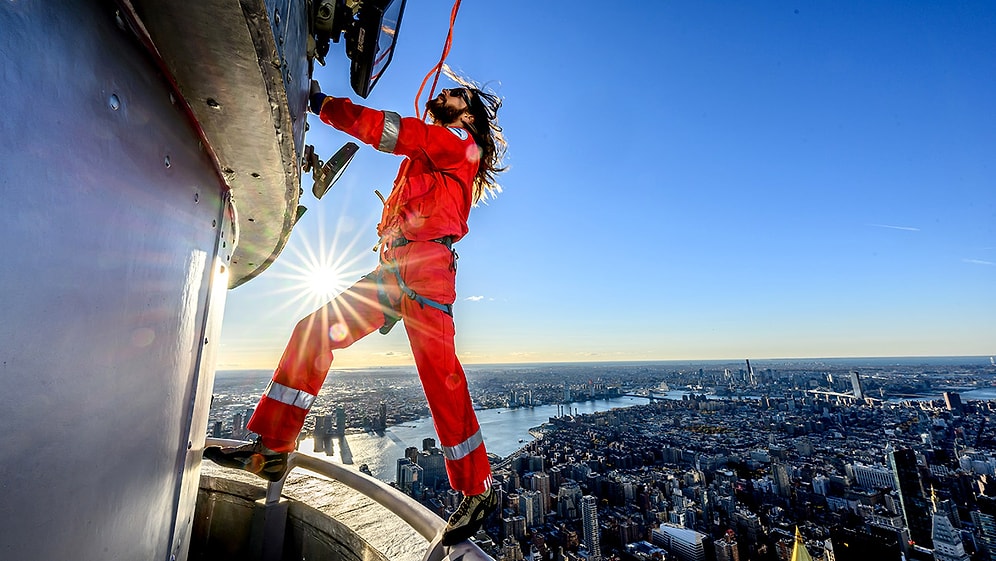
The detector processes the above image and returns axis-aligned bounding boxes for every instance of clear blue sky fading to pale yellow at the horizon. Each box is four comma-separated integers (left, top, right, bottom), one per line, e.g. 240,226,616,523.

218,0,996,369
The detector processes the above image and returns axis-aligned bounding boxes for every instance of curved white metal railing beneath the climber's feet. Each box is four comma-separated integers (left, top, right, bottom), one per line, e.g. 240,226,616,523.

205,438,494,561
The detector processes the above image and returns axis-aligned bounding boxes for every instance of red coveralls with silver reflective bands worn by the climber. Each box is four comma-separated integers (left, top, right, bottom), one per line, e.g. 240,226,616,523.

248,97,491,495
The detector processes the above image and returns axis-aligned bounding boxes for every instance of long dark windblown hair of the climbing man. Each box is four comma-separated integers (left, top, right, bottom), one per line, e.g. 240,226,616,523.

443,66,508,203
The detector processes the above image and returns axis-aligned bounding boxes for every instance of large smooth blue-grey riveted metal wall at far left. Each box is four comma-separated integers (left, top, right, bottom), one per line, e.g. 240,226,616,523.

0,0,234,560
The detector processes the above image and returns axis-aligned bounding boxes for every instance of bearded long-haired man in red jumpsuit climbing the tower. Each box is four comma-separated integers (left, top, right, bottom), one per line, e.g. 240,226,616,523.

204,77,505,545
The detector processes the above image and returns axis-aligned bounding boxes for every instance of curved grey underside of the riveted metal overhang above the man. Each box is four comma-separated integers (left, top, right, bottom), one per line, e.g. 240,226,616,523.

127,0,309,287
